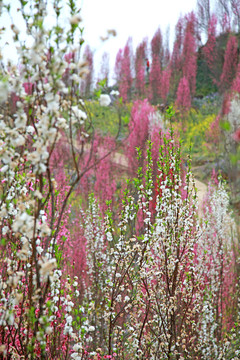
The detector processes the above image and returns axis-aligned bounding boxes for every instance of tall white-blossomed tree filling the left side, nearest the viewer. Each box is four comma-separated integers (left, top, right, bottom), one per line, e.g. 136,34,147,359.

0,0,117,359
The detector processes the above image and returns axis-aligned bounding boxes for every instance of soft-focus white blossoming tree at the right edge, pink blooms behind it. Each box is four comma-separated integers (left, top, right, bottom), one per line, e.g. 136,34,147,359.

197,181,238,359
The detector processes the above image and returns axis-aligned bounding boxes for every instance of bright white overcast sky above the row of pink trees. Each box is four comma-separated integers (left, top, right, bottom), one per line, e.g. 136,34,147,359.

0,0,197,83
